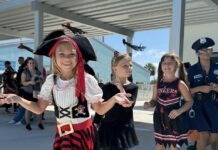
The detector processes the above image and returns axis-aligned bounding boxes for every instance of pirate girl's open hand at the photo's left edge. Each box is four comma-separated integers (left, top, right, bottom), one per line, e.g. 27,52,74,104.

0,94,18,104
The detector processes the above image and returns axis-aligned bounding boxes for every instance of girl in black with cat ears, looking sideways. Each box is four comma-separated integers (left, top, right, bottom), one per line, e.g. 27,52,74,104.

94,54,139,150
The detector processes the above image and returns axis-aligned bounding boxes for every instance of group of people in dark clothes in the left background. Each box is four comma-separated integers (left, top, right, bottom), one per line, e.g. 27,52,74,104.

1,57,45,130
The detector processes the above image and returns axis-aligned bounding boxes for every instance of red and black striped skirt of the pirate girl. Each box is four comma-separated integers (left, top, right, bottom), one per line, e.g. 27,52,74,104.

53,119,95,150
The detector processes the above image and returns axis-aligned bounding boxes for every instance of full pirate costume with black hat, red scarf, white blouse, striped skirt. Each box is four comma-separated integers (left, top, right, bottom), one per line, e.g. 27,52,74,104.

35,30,103,150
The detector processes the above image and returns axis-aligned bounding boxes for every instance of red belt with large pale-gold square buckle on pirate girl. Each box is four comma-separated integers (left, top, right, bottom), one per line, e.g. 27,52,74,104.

56,119,92,137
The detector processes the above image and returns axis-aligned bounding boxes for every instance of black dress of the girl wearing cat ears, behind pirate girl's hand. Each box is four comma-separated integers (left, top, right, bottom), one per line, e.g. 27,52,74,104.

93,83,139,150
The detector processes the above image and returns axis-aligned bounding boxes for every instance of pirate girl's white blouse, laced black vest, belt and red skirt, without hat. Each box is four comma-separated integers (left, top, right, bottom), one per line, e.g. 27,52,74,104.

39,74,102,150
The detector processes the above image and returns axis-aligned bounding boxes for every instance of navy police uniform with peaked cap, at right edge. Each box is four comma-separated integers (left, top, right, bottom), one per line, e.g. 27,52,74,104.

188,38,218,133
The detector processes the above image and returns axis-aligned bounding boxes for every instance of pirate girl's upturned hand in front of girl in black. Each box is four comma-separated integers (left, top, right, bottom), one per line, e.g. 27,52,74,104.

114,93,133,107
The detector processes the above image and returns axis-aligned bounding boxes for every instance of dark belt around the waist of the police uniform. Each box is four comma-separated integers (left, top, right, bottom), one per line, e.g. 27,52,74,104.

194,91,218,101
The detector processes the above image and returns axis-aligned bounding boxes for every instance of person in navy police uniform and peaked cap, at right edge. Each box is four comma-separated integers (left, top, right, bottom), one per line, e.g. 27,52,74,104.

188,37,218,150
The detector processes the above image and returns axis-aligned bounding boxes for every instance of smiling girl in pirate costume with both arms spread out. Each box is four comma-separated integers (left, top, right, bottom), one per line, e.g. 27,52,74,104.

0,30,132,150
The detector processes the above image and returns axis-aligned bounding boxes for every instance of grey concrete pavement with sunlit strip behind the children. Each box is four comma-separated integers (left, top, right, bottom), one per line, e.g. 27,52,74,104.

0,101,211,150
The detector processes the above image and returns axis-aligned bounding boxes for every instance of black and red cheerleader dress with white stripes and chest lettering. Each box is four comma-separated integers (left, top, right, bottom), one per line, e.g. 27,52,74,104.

153,79,187,148
